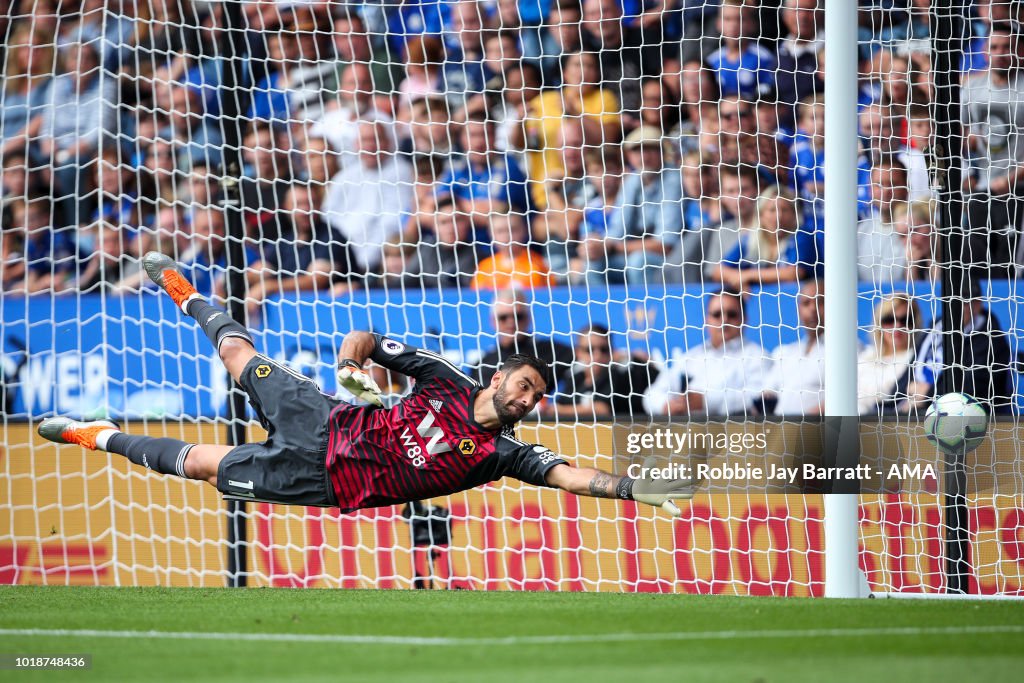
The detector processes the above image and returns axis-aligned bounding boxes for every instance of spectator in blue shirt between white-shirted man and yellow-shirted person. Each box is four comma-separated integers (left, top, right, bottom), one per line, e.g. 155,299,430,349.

438,115,529,226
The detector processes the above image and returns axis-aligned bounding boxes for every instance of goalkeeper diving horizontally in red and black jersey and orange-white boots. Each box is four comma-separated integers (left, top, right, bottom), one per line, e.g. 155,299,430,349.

39,252,692,515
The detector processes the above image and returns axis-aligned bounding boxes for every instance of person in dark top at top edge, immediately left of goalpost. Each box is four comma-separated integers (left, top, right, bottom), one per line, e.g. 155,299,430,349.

775,0,825,118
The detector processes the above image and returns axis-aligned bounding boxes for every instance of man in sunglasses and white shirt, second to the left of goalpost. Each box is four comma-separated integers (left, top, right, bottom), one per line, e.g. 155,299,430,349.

643,290,765,417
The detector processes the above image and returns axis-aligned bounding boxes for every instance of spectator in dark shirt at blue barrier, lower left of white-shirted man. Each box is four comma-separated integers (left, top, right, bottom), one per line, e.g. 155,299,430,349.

249,183,350,313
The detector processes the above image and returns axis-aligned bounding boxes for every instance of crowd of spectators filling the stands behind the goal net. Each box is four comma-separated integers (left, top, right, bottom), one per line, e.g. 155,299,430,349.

0,0,1024,417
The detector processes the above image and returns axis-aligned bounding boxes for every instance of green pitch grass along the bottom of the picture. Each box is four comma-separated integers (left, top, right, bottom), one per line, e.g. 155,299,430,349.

0,587,1024,683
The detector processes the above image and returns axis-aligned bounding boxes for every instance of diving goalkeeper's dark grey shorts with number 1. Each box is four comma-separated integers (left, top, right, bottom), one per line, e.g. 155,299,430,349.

217,354,341,507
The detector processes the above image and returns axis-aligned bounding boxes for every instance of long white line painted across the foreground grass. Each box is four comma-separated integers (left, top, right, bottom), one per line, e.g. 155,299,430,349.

0,625,1024,646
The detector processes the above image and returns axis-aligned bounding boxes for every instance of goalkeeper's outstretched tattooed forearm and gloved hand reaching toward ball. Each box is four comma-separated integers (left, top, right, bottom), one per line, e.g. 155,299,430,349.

545,465,694,517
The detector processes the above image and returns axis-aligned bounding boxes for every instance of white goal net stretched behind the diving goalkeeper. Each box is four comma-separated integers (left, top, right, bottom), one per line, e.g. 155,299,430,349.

0,0,1024,595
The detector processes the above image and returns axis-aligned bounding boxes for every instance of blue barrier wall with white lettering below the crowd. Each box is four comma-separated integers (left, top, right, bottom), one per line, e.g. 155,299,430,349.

0,282,1022,418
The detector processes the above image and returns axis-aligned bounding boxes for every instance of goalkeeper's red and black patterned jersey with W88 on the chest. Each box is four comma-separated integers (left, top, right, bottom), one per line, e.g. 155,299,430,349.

327,335,565,511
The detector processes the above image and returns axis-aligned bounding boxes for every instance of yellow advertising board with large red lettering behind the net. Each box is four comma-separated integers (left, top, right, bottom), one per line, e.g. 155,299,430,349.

0,423,1024,596
